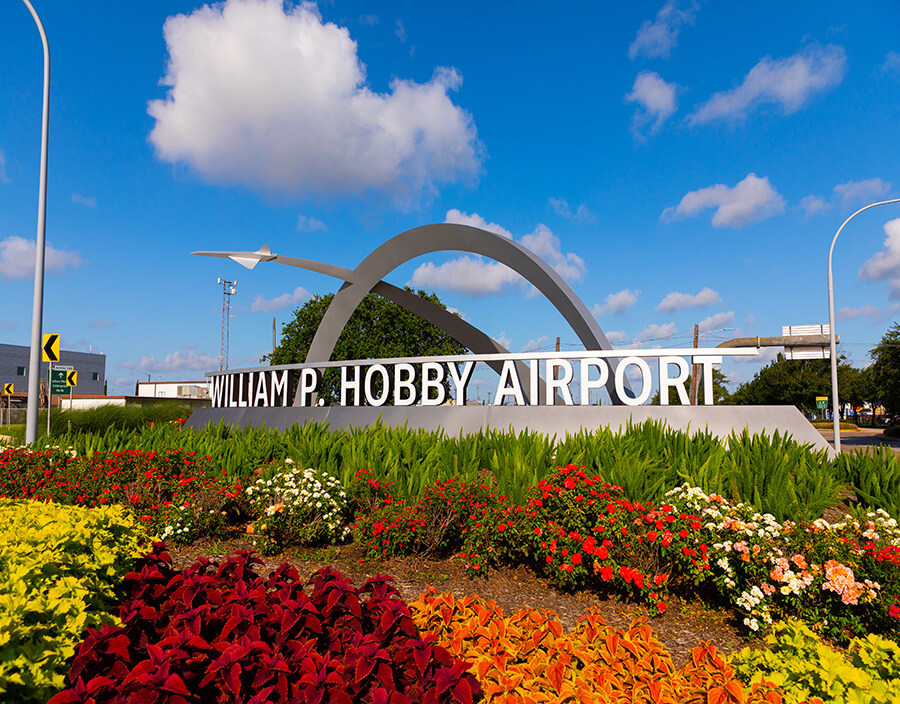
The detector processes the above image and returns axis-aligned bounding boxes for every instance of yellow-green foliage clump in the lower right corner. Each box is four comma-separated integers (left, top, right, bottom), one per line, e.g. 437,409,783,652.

732,620,900,704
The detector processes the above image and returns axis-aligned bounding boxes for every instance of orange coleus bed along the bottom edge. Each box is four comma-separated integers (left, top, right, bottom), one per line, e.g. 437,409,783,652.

410,589,824,704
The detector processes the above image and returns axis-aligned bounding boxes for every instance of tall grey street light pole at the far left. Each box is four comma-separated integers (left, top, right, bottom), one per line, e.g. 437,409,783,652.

22,0,50,443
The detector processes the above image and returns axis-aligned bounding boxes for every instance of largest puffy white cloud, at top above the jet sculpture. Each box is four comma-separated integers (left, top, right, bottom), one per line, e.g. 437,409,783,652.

148,0,483,205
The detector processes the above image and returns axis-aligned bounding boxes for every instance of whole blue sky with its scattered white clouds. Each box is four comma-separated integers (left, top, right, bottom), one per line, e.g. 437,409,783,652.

0,0,900,393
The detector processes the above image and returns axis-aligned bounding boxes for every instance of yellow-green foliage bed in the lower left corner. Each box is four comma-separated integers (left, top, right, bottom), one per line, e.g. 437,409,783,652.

0,499,145,702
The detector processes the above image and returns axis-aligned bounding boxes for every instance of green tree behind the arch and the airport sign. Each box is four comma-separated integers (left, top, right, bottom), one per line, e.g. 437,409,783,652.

263,287,466,403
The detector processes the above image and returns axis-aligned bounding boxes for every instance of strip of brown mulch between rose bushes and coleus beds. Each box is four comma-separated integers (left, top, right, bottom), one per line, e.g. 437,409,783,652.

169,537,761,667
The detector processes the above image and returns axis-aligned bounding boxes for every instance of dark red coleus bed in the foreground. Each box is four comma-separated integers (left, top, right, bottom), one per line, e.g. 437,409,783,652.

51,544,481,704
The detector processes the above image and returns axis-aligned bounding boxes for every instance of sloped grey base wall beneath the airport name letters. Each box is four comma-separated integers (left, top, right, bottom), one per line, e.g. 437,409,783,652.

185,406,834,455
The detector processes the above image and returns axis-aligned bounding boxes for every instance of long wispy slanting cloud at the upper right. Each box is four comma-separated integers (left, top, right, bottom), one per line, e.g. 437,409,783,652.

688,44,847,125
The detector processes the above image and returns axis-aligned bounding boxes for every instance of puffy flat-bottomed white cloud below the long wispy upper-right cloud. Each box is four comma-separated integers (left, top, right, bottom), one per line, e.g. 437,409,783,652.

660,173,784,228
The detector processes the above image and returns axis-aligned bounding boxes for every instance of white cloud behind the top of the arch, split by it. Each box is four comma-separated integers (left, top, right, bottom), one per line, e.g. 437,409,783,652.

410,209,585,296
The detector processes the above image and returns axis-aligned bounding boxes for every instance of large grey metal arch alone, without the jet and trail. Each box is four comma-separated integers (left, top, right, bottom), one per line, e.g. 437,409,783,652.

302,223,621,405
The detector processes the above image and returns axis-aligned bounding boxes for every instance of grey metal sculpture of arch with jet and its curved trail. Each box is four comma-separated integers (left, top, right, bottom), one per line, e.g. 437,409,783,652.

193,223,630,405
